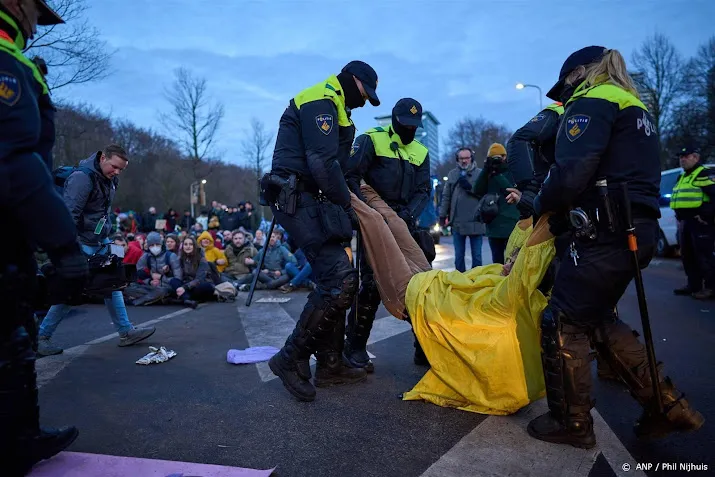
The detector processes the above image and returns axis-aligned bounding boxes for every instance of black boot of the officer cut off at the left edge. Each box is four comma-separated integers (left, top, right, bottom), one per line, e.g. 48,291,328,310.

0,327,79,476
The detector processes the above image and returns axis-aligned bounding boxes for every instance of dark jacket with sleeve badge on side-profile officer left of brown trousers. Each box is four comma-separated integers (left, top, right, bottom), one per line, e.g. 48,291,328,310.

272,76,355,208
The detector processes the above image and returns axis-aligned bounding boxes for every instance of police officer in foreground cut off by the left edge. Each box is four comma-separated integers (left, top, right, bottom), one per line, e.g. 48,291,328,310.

0,0,87,476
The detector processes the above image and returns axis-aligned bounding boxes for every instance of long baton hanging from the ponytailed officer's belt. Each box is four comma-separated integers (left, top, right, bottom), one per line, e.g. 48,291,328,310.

621,182,663,414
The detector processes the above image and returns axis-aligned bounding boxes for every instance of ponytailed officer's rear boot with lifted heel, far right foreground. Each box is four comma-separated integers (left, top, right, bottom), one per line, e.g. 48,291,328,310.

594,320,705,438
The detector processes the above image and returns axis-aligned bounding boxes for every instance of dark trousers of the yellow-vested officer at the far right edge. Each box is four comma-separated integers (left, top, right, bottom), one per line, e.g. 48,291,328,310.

679,218,715,292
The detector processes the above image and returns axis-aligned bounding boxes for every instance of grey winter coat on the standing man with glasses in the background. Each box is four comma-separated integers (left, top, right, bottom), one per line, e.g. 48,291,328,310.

439,163,490,236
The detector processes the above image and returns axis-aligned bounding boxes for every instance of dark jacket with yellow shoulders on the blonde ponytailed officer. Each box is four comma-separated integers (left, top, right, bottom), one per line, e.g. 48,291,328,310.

534,83,660,217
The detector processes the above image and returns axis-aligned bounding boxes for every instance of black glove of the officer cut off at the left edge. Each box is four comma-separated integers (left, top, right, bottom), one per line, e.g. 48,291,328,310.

47,244,89,305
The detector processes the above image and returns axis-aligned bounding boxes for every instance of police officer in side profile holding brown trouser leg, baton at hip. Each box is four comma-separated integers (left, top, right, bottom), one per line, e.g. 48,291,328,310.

262,61,380,401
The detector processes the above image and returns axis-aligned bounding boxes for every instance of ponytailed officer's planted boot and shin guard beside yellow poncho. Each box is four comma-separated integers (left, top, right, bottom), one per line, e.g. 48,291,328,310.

527,307,596,449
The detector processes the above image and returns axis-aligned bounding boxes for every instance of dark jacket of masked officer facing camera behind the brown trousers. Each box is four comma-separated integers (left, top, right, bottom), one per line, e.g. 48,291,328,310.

344,127,432,217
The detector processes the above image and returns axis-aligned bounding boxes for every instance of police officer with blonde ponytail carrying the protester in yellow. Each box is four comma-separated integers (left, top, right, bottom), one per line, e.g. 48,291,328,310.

528,46,703,448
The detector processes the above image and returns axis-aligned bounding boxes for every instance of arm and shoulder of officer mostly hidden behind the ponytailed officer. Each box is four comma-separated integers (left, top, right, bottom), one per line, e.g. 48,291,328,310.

506,101,564,218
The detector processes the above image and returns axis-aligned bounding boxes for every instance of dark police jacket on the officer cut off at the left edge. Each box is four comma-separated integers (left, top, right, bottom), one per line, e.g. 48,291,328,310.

0,13,77,260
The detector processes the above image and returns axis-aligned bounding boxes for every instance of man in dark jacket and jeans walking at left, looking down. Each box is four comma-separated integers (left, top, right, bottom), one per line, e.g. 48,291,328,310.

37,144,156,356
